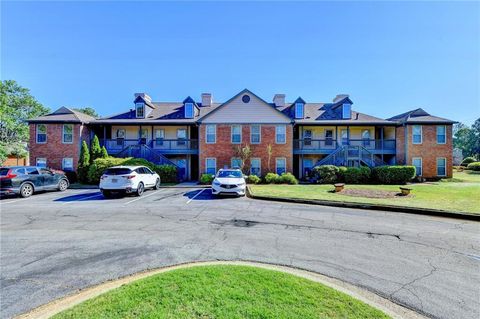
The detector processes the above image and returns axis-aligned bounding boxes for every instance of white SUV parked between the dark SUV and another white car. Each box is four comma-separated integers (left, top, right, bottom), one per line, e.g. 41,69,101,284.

99,166,160,197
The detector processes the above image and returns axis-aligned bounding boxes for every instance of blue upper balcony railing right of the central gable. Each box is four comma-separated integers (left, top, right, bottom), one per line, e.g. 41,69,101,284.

293,138,396,151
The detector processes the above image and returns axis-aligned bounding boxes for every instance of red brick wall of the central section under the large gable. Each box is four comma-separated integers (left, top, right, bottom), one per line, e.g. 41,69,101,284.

199,124,293,175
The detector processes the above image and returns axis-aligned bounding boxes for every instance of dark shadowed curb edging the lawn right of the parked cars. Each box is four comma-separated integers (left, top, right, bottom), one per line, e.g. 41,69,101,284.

247,186,480,221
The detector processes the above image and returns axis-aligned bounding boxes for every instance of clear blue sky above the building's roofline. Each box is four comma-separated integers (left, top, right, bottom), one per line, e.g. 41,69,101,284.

1,1,480,124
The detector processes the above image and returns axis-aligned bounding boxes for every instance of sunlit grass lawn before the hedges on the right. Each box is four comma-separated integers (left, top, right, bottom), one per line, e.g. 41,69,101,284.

250,172,480,214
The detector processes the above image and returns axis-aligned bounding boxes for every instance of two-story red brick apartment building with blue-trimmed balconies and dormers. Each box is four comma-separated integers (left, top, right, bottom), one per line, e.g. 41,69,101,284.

29,89,455,180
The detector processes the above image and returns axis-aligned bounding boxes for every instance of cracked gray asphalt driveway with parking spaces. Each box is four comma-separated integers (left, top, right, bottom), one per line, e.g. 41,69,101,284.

0,188,480,319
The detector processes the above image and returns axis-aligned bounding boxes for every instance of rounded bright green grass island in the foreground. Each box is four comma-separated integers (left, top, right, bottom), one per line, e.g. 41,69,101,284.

53,266,389,319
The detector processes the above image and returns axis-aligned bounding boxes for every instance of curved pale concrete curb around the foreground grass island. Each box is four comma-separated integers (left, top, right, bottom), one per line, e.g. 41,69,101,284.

15,260,426,319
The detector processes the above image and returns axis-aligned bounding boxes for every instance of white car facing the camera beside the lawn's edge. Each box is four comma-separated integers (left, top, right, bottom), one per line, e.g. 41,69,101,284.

212,169,246,196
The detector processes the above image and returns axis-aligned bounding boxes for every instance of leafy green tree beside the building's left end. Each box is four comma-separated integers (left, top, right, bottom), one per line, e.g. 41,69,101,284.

0,80,49,156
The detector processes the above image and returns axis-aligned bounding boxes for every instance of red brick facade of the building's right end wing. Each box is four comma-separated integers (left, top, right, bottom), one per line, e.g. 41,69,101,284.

396,125,453,178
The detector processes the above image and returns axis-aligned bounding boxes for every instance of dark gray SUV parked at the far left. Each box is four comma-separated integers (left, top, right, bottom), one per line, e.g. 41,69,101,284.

0,166,69,197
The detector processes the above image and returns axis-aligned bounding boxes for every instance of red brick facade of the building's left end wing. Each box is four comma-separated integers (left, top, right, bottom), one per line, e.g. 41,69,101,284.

29,123,90,170
